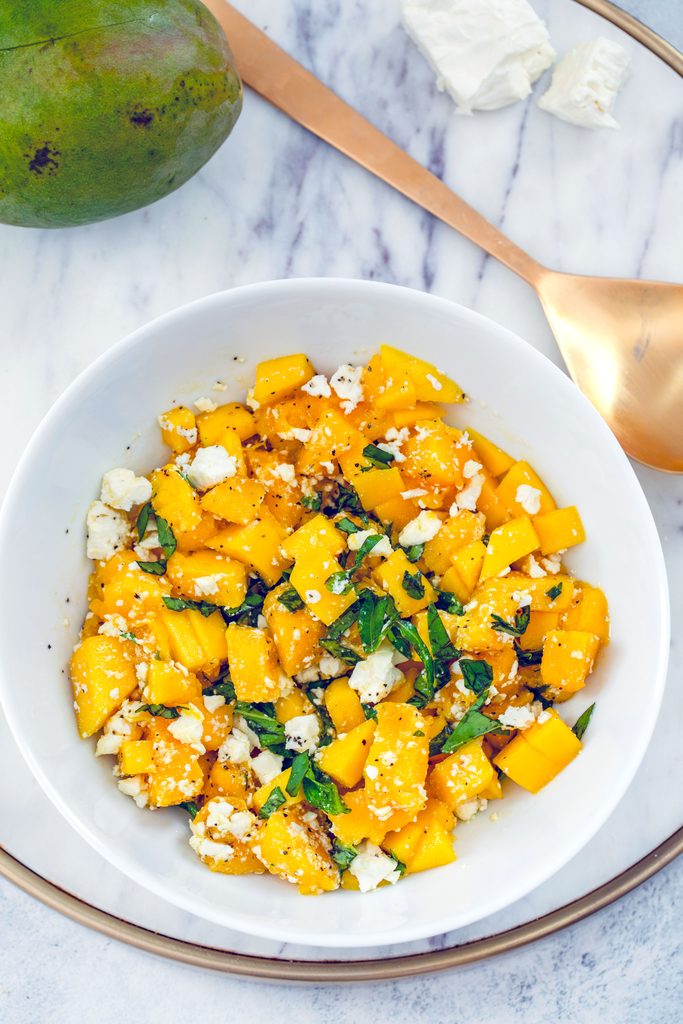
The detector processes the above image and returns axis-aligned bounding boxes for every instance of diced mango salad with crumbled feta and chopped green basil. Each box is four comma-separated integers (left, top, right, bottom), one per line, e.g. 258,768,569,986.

71,345,609,894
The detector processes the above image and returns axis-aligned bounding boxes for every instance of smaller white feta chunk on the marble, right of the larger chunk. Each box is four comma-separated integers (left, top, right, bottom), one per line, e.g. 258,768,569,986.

539,37,630,128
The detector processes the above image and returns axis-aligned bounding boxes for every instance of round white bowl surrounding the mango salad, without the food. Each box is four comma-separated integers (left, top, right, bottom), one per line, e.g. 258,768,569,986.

0,280,669,946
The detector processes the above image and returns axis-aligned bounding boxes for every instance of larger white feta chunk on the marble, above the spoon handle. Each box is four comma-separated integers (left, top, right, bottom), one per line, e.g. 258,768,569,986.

401,0,555,114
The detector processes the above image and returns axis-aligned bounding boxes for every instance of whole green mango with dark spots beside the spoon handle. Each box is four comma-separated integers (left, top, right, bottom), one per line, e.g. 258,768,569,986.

0,0,242,227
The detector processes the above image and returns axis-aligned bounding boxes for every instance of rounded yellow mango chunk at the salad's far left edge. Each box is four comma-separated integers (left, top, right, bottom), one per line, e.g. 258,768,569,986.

71,635,137,737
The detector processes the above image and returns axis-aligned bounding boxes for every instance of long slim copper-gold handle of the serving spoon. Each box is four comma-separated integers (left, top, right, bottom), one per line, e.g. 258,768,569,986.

204,0,544,287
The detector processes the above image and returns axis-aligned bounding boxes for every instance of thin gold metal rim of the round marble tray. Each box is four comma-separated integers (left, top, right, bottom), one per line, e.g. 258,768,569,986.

0,0,683,983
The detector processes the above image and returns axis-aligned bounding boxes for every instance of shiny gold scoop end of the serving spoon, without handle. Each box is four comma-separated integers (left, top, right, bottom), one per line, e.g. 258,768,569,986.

533,270,683,473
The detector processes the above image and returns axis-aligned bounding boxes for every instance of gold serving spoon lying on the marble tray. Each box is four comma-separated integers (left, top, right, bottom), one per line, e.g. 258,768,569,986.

205,0,683,473
